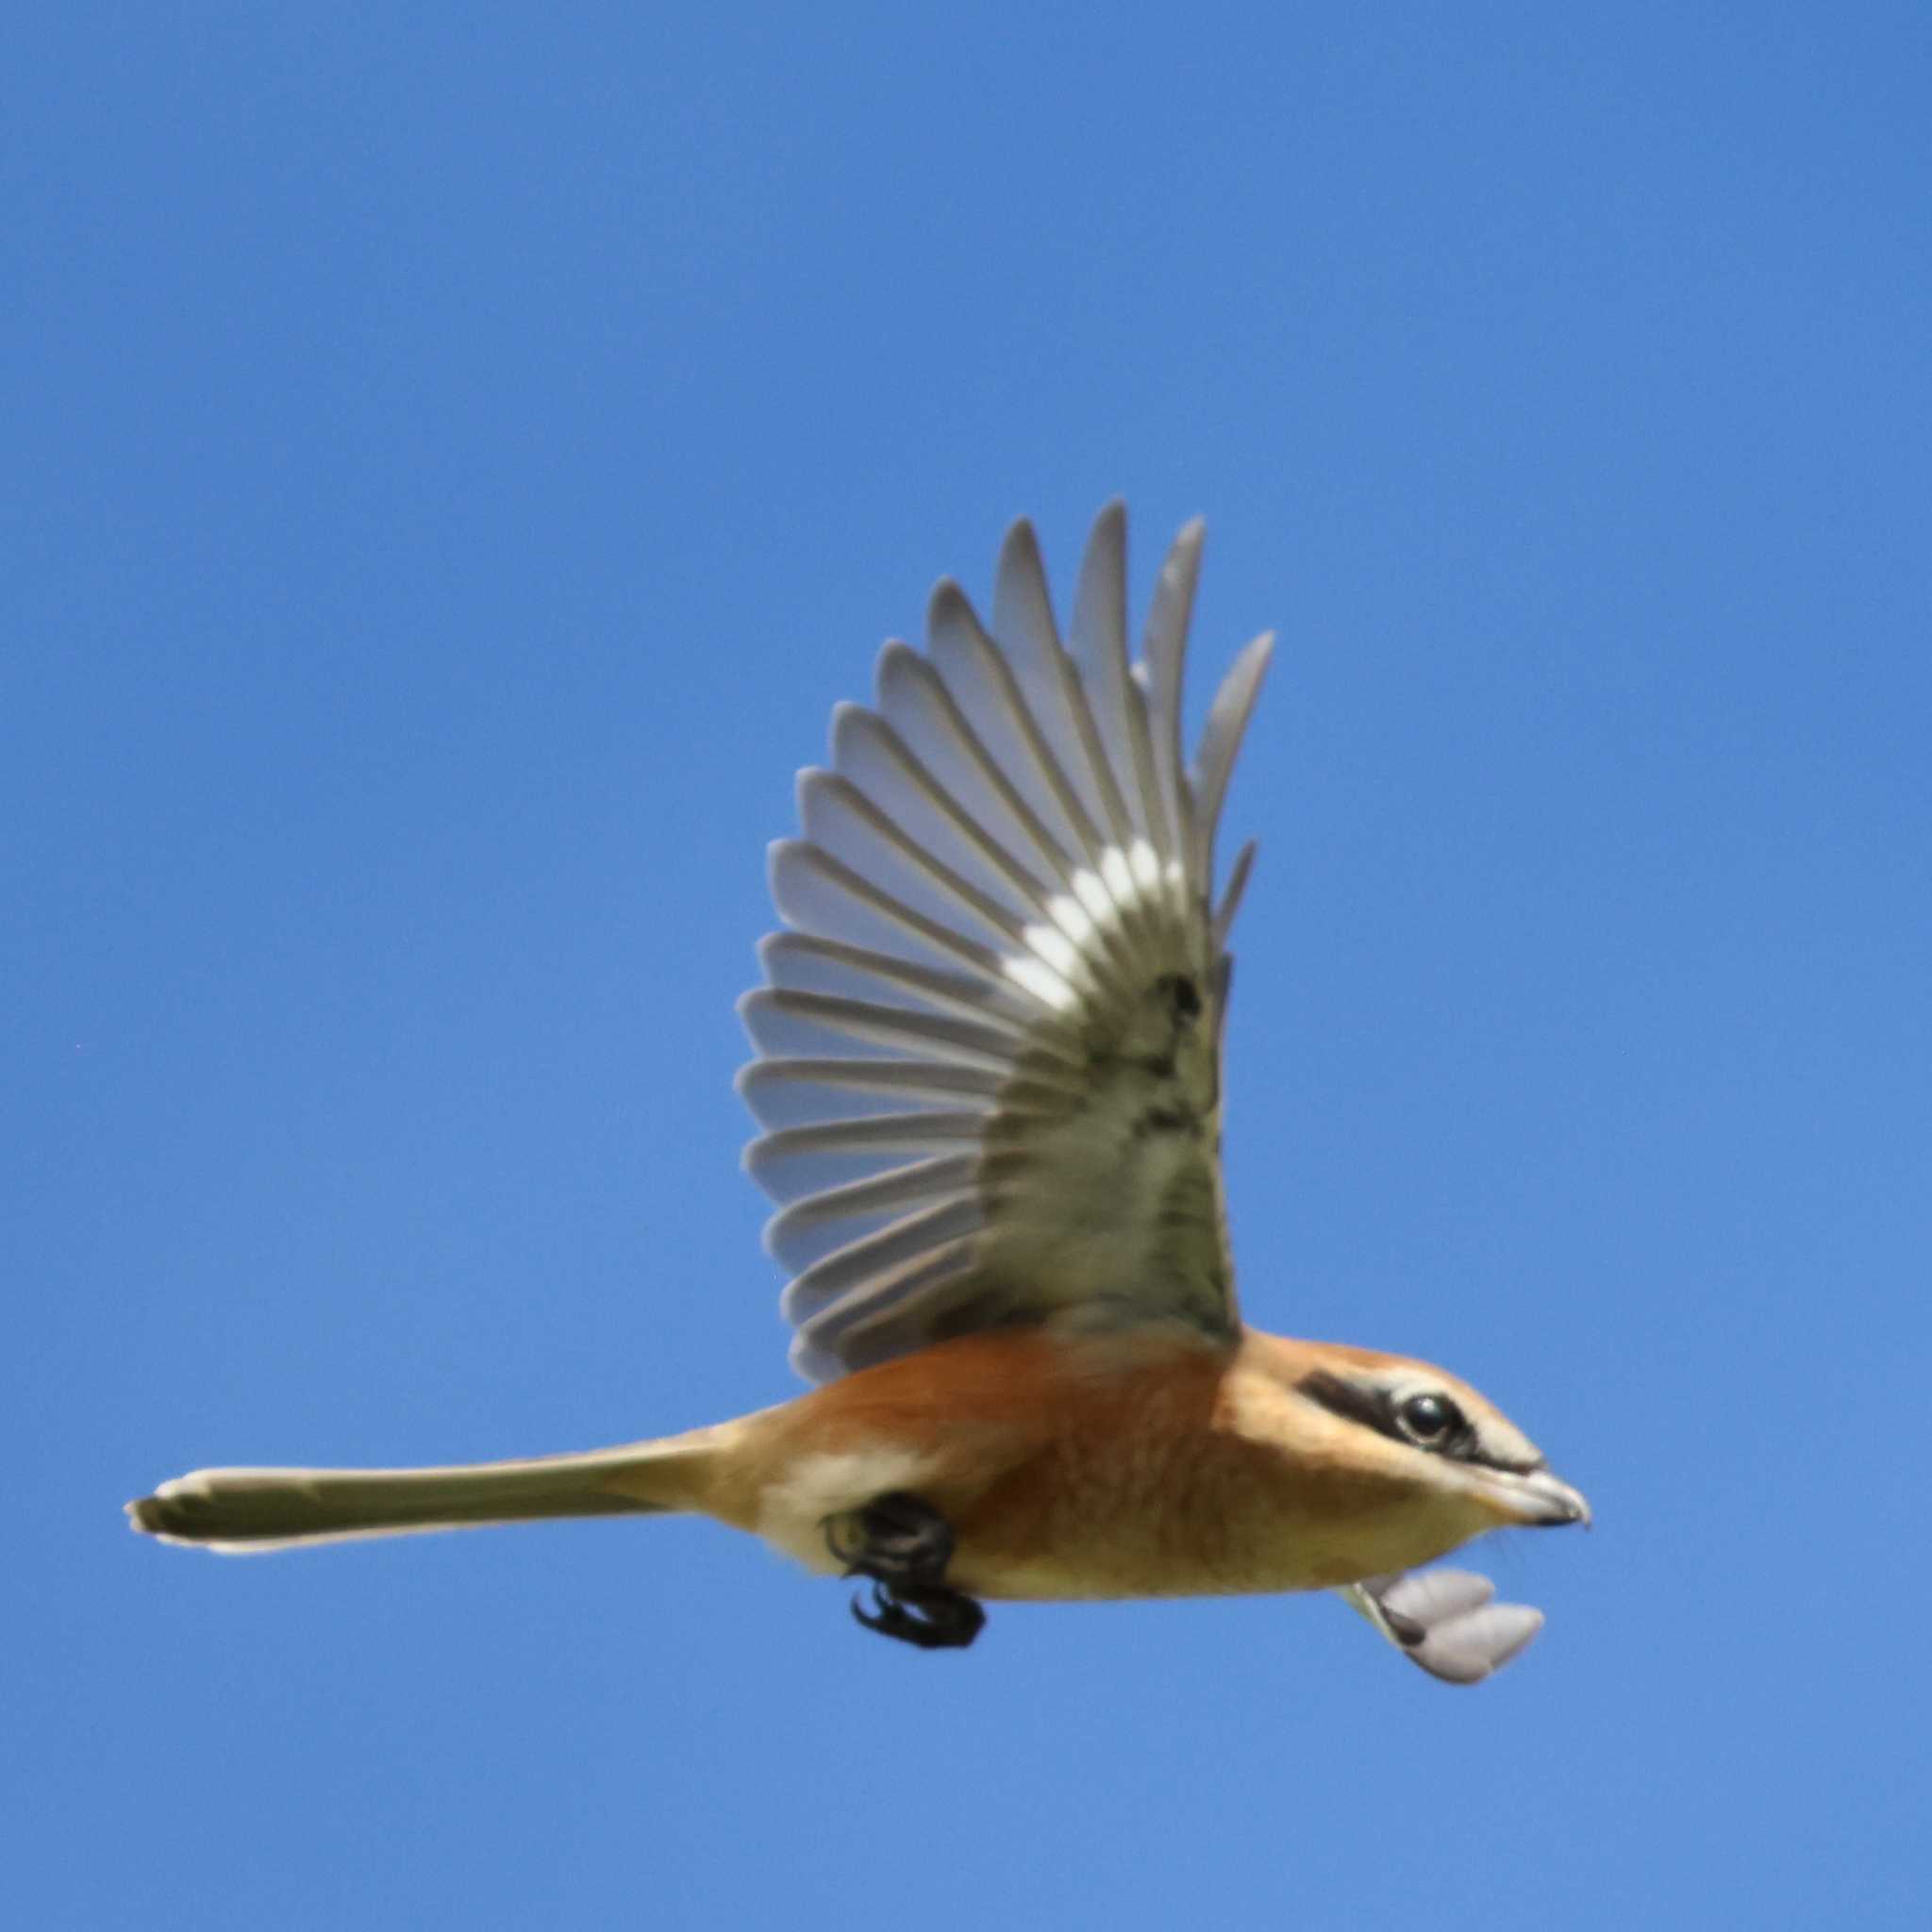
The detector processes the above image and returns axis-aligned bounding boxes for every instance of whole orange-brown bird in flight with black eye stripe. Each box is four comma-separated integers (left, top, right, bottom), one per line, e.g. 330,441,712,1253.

127,505,1591,1683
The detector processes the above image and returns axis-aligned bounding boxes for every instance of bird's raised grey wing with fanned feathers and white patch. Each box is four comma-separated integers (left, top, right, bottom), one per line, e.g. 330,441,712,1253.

740,505,1274,1381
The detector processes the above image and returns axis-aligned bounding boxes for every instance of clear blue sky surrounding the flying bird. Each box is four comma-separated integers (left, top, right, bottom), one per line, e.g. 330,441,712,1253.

0,4,1932,1932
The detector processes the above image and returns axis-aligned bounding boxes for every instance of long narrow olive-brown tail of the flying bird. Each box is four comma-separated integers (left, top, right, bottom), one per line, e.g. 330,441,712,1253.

127,1430,715,1554
